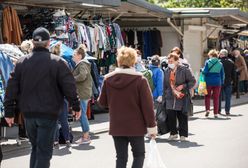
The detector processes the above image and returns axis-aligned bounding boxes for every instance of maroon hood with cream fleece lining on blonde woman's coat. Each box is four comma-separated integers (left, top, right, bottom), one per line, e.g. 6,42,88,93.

105,68,142,89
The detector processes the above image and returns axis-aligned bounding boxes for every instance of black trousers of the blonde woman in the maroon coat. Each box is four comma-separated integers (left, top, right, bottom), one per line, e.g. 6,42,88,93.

113,136,145,168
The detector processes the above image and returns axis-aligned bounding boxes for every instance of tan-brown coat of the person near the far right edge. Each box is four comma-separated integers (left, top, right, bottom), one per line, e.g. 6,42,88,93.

235,55,248,81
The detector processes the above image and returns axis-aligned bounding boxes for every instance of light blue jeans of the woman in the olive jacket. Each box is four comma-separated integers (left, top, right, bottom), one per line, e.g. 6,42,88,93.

80,100,90,133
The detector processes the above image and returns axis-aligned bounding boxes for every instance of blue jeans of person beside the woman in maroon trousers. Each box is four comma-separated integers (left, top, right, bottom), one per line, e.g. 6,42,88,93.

219,85,232,113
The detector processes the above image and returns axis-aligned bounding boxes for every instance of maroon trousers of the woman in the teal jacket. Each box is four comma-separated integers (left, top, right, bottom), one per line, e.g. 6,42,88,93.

205,86,221,114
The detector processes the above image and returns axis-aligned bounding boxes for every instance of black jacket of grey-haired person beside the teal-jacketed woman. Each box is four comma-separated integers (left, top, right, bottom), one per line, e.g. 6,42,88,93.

220,57,236,86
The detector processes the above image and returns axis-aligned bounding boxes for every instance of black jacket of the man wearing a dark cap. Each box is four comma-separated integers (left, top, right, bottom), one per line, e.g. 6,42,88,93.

4,48,80,119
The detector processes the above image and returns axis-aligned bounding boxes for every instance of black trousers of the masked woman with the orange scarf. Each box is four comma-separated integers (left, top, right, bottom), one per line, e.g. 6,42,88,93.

168,110,188,137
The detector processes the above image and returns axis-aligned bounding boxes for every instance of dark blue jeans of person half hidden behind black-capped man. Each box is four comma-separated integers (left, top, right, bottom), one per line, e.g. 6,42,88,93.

55,100,70,142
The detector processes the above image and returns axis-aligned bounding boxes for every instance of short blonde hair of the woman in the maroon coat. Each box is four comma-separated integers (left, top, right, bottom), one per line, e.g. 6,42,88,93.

117,47,137,67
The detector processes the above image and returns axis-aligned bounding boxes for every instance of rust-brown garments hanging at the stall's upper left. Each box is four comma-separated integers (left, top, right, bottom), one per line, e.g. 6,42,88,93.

2,6,23,45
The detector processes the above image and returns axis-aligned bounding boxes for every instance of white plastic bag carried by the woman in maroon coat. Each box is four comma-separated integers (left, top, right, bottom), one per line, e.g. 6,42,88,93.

144,139,166,168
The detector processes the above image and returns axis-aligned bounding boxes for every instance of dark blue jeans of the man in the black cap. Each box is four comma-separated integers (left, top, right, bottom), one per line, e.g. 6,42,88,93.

25,118,57,168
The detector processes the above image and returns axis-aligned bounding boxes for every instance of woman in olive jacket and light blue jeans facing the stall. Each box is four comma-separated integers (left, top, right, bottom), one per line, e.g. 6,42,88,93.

73,45,93,144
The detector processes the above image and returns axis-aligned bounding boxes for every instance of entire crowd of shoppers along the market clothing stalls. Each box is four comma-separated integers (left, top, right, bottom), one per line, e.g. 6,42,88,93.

0,28,248,168
